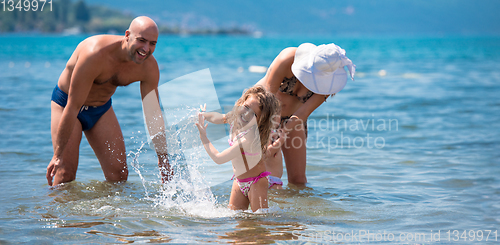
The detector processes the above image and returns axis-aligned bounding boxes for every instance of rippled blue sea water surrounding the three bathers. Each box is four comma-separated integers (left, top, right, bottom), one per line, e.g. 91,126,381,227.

0,35,500,244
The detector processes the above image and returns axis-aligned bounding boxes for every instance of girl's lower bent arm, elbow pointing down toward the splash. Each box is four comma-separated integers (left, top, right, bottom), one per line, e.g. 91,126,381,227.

196,113,241,164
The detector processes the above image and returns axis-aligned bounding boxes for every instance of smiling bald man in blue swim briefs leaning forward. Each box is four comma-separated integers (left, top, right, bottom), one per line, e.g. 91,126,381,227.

46,16,171,186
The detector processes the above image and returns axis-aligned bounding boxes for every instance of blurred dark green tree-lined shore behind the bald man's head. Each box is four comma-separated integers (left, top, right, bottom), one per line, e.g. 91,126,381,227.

0,0,256,36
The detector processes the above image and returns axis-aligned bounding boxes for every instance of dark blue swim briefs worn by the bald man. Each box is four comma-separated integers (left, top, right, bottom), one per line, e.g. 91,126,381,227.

52,85,111,131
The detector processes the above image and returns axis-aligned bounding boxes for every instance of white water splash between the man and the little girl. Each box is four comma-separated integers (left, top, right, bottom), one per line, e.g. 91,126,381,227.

128,108,235,218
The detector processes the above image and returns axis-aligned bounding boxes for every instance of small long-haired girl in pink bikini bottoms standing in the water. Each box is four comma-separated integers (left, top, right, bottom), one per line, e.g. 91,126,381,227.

196,86,280,212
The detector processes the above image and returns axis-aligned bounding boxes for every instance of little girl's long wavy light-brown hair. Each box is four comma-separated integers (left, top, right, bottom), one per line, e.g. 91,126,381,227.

228,85,281,153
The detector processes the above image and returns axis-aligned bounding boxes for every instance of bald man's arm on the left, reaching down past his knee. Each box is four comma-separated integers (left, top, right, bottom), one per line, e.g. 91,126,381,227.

46,50,102,186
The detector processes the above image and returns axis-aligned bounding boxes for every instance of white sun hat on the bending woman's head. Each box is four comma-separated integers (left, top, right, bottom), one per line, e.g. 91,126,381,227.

292,43,356,95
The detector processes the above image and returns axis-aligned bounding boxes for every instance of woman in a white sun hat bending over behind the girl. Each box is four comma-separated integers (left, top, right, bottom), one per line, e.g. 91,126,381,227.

257,43,356,184
